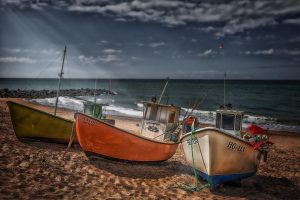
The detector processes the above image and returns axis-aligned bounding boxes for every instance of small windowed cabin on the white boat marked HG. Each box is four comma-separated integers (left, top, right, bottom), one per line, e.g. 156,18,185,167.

216,109,244,137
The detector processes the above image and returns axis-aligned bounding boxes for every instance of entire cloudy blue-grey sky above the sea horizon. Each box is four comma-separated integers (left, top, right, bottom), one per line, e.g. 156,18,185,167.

0,0,300,80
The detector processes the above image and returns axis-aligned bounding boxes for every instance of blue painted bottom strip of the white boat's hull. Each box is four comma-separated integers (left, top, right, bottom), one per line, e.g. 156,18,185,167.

197,170,256,188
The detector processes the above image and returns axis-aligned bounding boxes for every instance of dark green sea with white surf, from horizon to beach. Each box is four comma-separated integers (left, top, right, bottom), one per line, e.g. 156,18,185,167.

0,78,300,133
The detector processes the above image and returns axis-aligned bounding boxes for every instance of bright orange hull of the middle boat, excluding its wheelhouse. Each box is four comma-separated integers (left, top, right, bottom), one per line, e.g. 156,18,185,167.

75,113,179,162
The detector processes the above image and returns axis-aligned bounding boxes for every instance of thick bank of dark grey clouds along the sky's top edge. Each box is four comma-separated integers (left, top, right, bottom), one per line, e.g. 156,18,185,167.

2,0,300,36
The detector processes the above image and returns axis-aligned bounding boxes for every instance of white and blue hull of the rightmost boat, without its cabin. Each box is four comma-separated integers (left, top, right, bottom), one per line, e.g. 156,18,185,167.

181,128,259,187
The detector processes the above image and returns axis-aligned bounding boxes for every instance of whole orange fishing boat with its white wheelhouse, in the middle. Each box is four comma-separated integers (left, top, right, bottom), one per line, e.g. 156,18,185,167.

75,102,180,162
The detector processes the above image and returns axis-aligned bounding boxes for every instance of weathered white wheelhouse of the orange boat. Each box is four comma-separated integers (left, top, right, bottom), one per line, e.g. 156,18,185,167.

141,102,180,141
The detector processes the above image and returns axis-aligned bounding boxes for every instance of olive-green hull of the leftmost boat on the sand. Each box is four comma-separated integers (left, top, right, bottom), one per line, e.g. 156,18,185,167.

7,101,77,143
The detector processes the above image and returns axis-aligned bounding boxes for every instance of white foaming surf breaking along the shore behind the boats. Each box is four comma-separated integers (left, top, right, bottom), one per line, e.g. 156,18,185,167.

31,96,300,133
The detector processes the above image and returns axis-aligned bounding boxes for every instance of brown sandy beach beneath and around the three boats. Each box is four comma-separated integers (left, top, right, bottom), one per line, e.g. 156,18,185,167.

0,98,300,199
